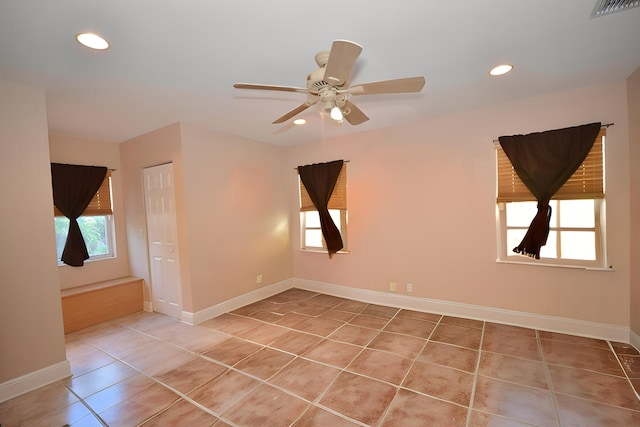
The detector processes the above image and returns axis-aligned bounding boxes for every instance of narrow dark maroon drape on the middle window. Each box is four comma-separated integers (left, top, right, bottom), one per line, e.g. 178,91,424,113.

298,160,344,257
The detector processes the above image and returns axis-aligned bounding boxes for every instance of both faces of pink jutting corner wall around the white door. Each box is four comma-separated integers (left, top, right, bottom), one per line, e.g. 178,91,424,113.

120,123,293,313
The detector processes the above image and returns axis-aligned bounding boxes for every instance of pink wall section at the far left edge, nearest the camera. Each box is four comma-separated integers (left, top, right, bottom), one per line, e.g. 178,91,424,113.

0,78,70,384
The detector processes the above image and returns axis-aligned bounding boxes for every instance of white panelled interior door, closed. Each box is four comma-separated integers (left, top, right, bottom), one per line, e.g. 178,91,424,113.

143,163,182,319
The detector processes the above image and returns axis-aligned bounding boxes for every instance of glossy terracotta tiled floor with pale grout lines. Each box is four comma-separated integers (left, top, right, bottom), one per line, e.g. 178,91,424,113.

0,289,640,427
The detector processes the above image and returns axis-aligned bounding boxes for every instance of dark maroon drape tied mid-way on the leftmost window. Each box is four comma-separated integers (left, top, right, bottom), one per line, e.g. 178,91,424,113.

51,163,107,267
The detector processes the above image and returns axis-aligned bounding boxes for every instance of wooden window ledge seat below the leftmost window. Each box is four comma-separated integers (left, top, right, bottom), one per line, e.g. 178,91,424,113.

61,276,143,334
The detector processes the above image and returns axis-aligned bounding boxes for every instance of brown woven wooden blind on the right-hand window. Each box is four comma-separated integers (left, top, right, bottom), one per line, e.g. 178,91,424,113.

496,128,606,202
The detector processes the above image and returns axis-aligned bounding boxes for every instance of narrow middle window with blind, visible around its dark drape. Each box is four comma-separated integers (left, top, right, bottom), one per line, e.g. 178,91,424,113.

298,163,348,252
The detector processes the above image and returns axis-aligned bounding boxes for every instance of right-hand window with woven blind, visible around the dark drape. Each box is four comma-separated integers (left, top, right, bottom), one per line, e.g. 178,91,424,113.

496,128,607,268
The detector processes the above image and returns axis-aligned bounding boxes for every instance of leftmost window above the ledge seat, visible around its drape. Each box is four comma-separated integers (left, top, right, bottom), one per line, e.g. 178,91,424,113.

54,172,115,263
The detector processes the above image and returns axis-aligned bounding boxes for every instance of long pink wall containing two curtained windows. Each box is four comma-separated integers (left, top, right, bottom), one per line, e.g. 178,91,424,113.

287,82,630,326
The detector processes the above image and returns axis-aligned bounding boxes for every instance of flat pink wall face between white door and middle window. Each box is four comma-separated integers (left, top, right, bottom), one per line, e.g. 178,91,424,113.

182,124,293,312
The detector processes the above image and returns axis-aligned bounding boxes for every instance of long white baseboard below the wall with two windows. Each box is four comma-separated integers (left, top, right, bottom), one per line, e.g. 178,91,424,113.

294,278,640,347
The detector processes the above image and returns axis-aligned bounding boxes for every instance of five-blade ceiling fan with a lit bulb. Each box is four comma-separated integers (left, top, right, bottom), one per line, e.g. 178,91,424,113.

233,40,425,125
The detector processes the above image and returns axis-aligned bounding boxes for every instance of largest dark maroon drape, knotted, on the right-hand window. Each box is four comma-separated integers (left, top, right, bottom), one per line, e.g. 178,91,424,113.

499,123,601,259
